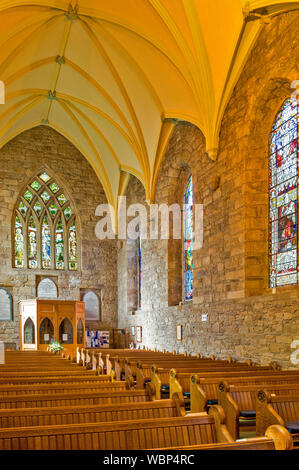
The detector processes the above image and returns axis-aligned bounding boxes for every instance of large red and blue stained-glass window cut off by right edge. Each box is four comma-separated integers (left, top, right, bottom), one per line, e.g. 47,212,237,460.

269,99,299,288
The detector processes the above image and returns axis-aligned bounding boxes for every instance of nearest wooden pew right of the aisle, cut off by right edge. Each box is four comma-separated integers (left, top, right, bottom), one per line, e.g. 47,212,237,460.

256,390,299,445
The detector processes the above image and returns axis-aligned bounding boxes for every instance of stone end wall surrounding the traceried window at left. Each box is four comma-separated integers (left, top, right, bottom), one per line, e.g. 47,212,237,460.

0,126,117,344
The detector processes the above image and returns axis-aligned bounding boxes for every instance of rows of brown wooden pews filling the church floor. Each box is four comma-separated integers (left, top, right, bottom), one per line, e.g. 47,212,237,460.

0,349,293,450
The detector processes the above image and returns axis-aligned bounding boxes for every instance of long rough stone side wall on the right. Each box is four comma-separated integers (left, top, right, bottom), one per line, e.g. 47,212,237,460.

119,12,299,367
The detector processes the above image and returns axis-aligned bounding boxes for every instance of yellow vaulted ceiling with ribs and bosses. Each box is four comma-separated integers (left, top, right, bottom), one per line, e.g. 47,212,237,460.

0,0,299,207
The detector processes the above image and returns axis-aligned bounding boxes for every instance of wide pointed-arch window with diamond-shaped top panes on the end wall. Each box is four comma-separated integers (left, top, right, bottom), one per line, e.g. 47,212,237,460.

13,171,78,271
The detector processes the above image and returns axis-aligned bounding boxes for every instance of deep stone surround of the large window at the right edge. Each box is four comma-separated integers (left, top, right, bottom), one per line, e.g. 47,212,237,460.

244,78,299,298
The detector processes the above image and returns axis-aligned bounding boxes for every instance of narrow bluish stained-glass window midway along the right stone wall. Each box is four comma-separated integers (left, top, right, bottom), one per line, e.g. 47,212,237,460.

184,176,193,300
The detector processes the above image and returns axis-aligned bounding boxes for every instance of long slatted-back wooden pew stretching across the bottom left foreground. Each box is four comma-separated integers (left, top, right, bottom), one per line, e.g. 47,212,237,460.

0,406,233,451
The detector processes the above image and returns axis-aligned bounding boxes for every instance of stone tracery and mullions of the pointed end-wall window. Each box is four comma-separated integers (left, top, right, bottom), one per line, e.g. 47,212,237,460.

11,165,82,277
